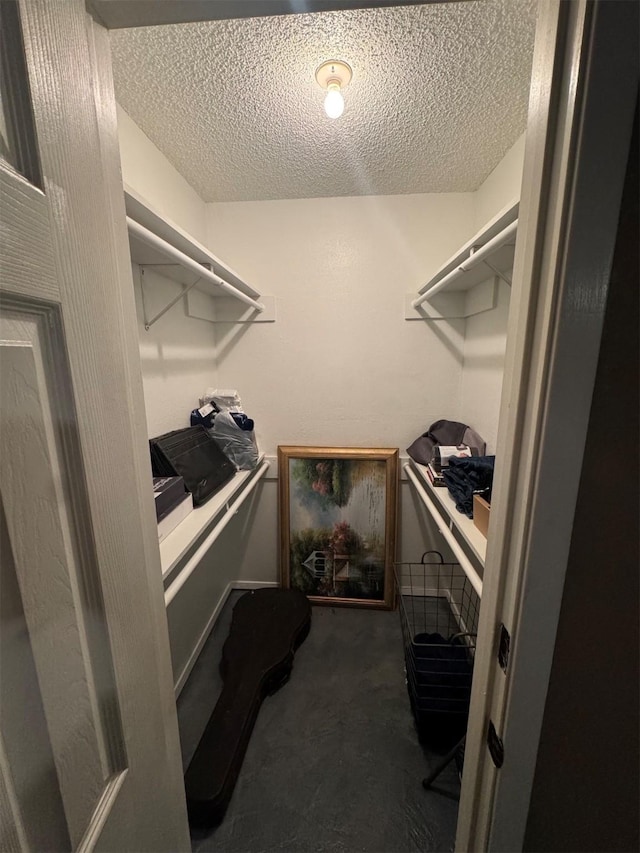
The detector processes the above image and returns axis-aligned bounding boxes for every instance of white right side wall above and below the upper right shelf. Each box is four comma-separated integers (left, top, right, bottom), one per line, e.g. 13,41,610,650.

460,134,525,453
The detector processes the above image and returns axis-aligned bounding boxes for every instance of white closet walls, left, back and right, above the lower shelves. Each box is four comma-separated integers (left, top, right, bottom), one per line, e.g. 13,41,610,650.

118,103,524,454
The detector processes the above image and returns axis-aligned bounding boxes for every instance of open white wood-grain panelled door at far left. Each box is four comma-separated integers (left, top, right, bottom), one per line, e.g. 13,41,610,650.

0,0,190,851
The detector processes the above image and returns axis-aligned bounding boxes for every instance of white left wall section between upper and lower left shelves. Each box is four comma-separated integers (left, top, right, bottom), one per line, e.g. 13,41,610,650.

132,264,216,438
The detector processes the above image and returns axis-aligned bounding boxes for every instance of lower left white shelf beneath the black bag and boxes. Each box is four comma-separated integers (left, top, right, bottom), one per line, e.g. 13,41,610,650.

160,453,264,580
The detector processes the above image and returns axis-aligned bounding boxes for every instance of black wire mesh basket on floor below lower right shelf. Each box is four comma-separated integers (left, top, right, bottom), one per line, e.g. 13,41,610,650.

395,551,480,750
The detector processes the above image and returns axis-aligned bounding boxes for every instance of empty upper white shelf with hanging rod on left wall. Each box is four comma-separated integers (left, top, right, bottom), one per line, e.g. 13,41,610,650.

124,186,260,299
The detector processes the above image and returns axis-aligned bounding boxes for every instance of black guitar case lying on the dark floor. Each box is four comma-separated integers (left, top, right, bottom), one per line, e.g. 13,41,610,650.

185,589,311,826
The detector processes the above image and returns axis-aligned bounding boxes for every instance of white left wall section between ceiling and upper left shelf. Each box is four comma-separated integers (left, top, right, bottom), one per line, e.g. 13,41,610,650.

118,106,205,242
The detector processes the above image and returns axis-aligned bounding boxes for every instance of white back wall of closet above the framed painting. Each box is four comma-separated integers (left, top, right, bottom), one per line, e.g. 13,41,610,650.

207,193,473,455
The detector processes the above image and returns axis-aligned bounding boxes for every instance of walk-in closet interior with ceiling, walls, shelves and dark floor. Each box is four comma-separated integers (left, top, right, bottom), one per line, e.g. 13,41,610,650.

111,0,537,850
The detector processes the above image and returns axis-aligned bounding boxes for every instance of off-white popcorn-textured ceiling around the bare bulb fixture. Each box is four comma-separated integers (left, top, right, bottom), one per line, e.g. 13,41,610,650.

111,0,535,201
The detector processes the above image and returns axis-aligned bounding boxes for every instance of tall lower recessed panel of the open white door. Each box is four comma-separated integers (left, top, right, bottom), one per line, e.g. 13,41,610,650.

0,300,124,847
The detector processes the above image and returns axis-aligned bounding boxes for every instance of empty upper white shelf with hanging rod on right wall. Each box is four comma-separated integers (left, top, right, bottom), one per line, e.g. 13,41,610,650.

418,201,520,295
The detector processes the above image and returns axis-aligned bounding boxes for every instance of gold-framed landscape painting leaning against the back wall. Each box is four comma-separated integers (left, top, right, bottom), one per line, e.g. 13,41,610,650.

278,447,398,609
